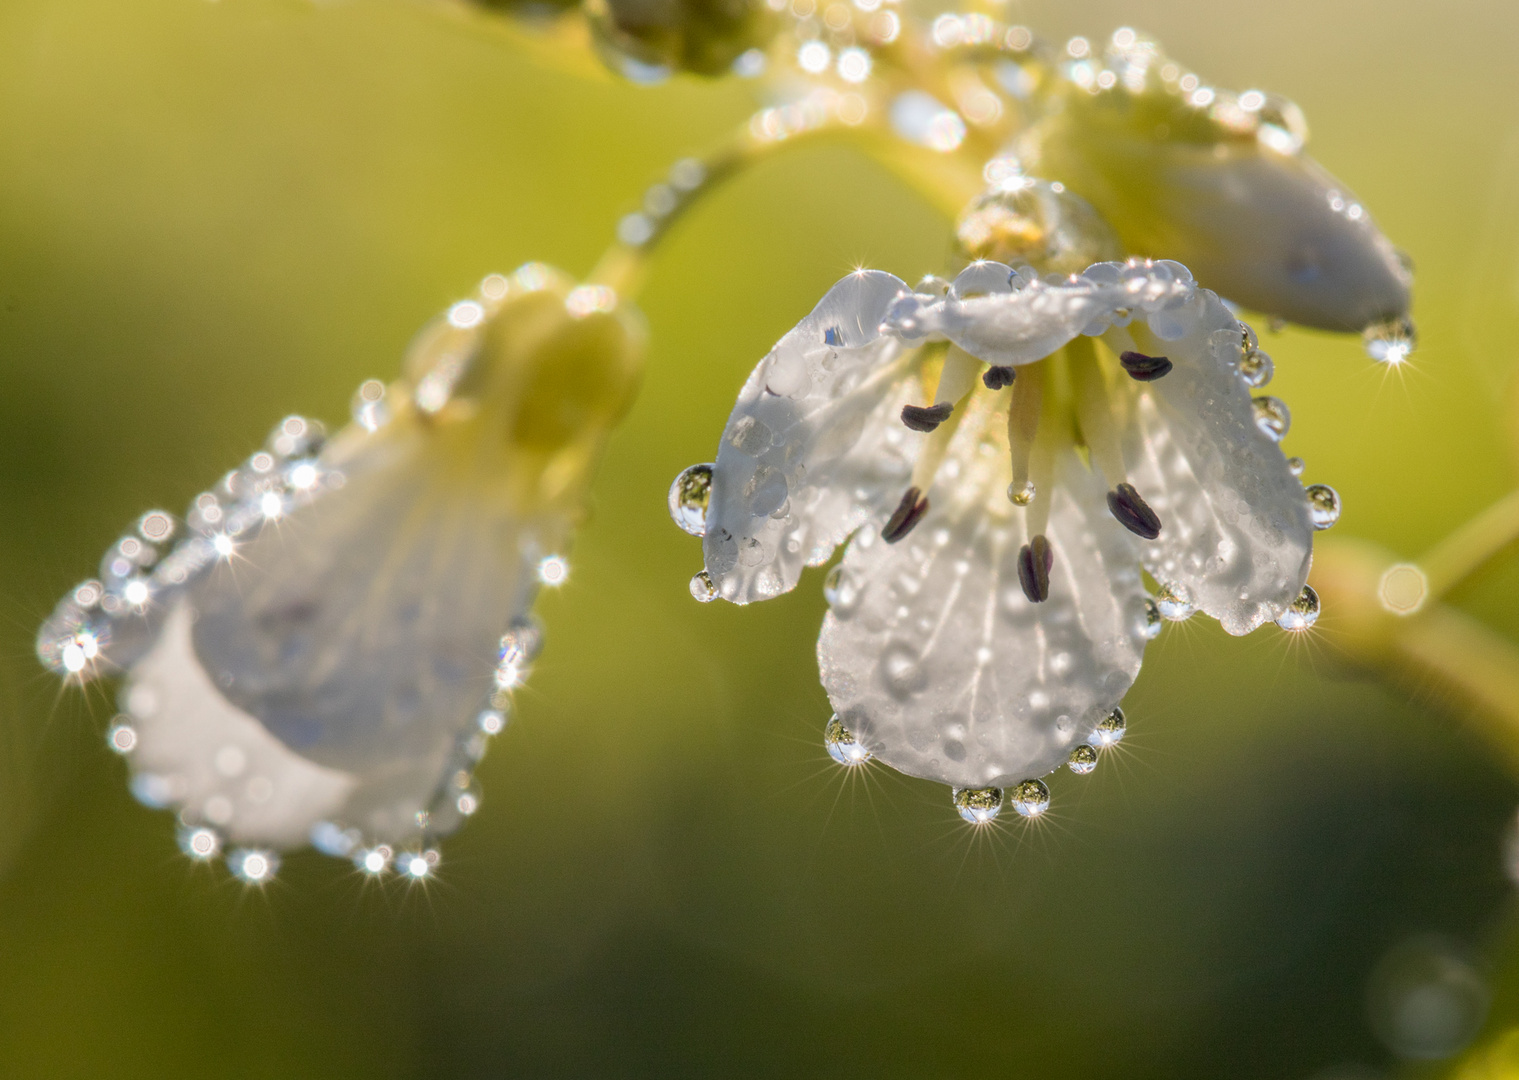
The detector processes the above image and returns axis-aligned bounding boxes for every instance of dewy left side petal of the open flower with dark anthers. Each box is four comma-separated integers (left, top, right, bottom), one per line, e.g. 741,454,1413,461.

702,270,924,603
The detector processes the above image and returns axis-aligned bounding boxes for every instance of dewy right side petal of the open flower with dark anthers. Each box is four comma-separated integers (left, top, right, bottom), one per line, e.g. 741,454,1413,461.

1124,290,1312,633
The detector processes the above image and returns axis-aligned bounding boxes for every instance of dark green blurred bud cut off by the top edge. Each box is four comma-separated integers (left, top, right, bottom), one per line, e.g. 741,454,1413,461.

585,0,775,82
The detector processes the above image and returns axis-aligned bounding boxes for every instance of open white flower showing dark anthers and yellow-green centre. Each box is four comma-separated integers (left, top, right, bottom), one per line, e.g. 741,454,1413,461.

671,261,1338,813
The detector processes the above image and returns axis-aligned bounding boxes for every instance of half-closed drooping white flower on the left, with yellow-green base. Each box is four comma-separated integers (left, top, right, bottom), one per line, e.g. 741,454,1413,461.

38,264,638,879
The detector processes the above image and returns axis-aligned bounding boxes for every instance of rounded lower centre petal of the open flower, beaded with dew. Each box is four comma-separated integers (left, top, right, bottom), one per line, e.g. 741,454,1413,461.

817,401,1147,787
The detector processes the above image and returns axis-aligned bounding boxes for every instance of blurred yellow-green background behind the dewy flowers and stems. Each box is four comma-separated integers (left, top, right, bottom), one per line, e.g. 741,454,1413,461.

0,0,1519,1080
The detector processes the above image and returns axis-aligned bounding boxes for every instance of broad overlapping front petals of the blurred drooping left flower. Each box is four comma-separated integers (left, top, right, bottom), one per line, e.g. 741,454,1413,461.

123,421,546,846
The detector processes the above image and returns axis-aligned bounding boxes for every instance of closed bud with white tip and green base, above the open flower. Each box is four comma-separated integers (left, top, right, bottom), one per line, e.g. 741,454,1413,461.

1018,30,1413,331
